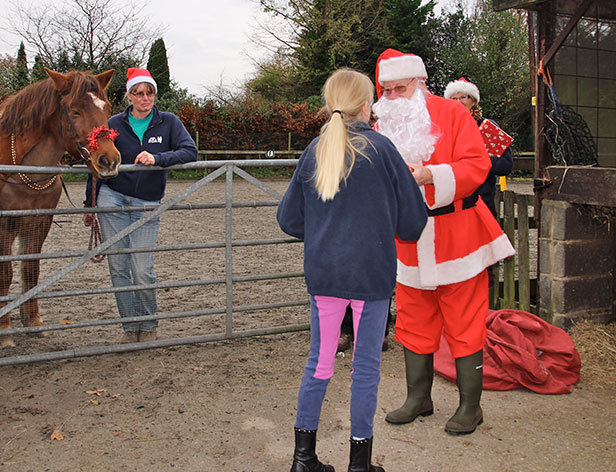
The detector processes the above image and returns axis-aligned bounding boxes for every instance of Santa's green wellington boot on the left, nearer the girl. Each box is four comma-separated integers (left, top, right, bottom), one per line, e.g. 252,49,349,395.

385,348,434,424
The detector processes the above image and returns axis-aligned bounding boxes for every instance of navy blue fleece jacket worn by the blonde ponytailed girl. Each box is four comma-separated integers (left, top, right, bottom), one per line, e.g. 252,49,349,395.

277,122,427,300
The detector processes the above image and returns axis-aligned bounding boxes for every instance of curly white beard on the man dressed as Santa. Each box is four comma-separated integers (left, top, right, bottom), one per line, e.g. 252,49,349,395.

372,88,439,164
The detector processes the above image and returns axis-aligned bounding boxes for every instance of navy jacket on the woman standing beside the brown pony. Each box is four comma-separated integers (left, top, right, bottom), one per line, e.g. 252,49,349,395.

84,105,198,206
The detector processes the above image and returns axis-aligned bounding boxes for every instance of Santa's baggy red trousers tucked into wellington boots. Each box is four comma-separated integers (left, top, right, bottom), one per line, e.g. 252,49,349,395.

394,270,488,358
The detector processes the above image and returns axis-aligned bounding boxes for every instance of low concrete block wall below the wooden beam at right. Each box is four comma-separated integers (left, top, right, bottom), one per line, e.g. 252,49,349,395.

539,200,616,328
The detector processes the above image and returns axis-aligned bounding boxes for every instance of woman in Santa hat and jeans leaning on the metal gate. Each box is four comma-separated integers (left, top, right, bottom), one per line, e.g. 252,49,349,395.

84,67,197,343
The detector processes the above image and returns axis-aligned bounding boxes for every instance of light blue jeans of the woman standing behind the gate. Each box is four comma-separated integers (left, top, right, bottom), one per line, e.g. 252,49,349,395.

97,184,160,331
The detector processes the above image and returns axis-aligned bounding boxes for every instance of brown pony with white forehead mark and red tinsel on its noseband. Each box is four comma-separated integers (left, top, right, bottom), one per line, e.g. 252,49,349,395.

0,69,121,348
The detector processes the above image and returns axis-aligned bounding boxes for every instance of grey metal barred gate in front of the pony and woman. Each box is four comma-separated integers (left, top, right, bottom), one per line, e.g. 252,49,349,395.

0,159,308,366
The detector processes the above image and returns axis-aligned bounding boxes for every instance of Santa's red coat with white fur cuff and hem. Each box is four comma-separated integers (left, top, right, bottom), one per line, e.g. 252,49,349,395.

396,93,515,290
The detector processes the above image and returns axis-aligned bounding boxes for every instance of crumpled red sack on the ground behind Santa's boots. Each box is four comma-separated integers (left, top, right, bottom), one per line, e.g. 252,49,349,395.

434,310,581,394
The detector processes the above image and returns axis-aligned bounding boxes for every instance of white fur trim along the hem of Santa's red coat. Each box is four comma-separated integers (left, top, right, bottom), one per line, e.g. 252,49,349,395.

398,232,515,290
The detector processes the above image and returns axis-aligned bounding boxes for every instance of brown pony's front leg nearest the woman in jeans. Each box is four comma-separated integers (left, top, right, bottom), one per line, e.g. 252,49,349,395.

19,216,53,337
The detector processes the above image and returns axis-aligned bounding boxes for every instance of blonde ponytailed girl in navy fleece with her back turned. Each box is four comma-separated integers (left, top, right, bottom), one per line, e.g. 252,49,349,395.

277,69,427,472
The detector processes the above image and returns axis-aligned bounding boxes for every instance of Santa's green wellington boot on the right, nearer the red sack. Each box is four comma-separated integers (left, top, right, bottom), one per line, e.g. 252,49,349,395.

445,350,483,435
